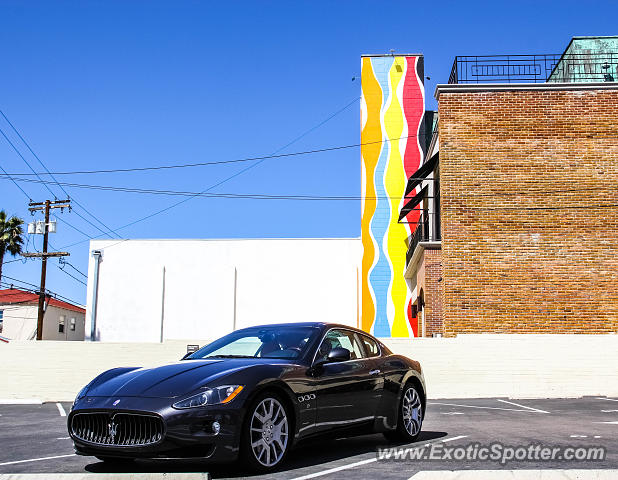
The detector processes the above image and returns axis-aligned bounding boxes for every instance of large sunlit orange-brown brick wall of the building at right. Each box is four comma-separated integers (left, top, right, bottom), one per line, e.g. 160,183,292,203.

439,89,618,336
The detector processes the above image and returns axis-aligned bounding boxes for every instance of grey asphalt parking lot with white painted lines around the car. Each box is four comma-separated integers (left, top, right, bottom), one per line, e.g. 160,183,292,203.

0,397,618,480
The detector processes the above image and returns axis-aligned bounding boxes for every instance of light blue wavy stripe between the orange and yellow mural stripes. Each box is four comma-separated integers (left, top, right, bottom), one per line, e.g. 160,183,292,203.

369,57,393,337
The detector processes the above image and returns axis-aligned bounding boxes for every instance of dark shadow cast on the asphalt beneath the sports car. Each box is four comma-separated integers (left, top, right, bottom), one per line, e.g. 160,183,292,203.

85,431,448,478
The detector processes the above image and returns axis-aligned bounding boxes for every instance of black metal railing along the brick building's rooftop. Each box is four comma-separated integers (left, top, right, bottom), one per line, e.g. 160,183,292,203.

448,52,618,83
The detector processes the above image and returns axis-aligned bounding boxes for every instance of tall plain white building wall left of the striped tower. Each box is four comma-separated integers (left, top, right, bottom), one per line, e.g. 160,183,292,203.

86,239,361,342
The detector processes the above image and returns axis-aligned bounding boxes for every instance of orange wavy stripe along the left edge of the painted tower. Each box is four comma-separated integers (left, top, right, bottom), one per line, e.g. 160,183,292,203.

361,58,382,332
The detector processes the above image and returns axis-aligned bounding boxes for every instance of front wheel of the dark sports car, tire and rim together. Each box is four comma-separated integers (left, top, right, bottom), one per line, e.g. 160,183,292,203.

241,392,292,472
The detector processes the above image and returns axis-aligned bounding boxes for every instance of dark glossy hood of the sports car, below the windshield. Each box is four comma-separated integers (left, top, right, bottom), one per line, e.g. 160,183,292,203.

86,358,278,398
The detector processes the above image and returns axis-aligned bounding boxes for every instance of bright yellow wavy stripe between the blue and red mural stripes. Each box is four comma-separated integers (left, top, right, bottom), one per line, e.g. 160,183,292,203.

384,57,409,337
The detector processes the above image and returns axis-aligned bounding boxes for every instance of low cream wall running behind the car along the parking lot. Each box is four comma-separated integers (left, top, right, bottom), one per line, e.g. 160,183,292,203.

0,335,618,401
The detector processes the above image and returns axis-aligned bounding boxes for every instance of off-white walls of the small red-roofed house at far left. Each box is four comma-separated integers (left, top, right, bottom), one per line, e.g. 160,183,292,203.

0,305,85,341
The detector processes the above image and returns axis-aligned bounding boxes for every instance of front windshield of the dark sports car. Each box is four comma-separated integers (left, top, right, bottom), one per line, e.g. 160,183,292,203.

187,326,319,359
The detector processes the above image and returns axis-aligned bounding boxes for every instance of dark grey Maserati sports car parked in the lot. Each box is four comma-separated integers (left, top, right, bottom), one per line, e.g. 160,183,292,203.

68,322,426,471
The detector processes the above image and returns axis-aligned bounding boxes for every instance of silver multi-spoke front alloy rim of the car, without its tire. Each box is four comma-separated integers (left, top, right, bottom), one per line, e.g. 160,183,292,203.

249,397,288,467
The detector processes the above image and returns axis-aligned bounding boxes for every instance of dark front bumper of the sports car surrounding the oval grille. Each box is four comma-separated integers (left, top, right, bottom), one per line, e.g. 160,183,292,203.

67,397,245,461
